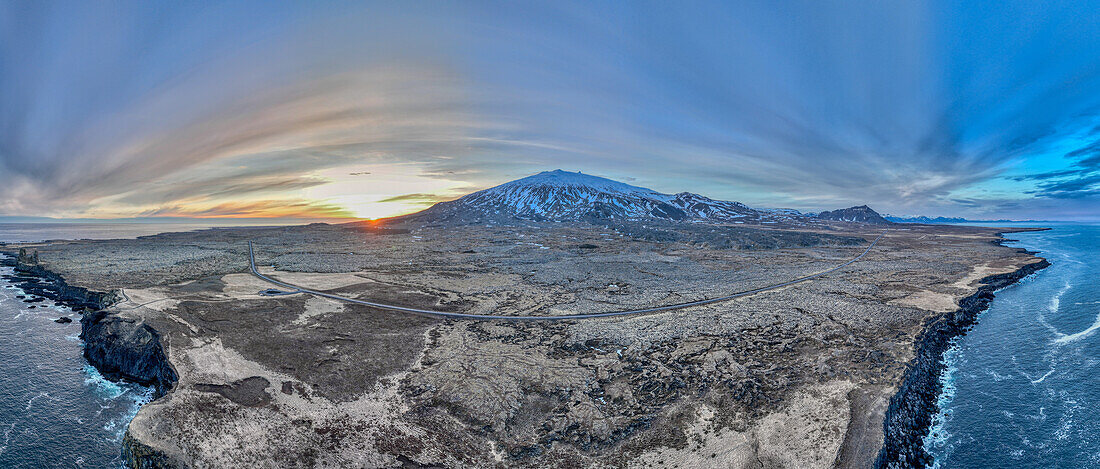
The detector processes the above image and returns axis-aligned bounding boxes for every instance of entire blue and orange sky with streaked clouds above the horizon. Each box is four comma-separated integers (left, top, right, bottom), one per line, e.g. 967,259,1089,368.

0,1,1100,220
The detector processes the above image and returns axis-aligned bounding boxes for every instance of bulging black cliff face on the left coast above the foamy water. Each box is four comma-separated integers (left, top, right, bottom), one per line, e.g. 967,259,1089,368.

80,310,176,395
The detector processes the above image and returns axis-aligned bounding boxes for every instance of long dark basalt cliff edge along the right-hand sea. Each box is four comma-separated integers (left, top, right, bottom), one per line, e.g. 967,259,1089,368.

875,253,1051,469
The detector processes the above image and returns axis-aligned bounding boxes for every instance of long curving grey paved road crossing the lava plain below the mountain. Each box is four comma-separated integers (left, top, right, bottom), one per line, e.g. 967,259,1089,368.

249,232,886,320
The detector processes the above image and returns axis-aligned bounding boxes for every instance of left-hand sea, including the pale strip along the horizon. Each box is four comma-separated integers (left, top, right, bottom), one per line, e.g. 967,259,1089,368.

0,223,240,469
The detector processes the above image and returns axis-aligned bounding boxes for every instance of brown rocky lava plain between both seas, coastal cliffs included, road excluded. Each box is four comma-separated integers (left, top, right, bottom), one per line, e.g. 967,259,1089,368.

2,218,1040,468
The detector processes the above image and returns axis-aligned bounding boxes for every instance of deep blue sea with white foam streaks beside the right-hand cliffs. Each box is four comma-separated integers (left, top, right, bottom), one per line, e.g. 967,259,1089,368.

925,223,1100,469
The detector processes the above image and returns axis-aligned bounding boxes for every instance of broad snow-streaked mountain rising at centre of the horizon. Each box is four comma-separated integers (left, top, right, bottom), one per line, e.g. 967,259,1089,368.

396,170,766,221
